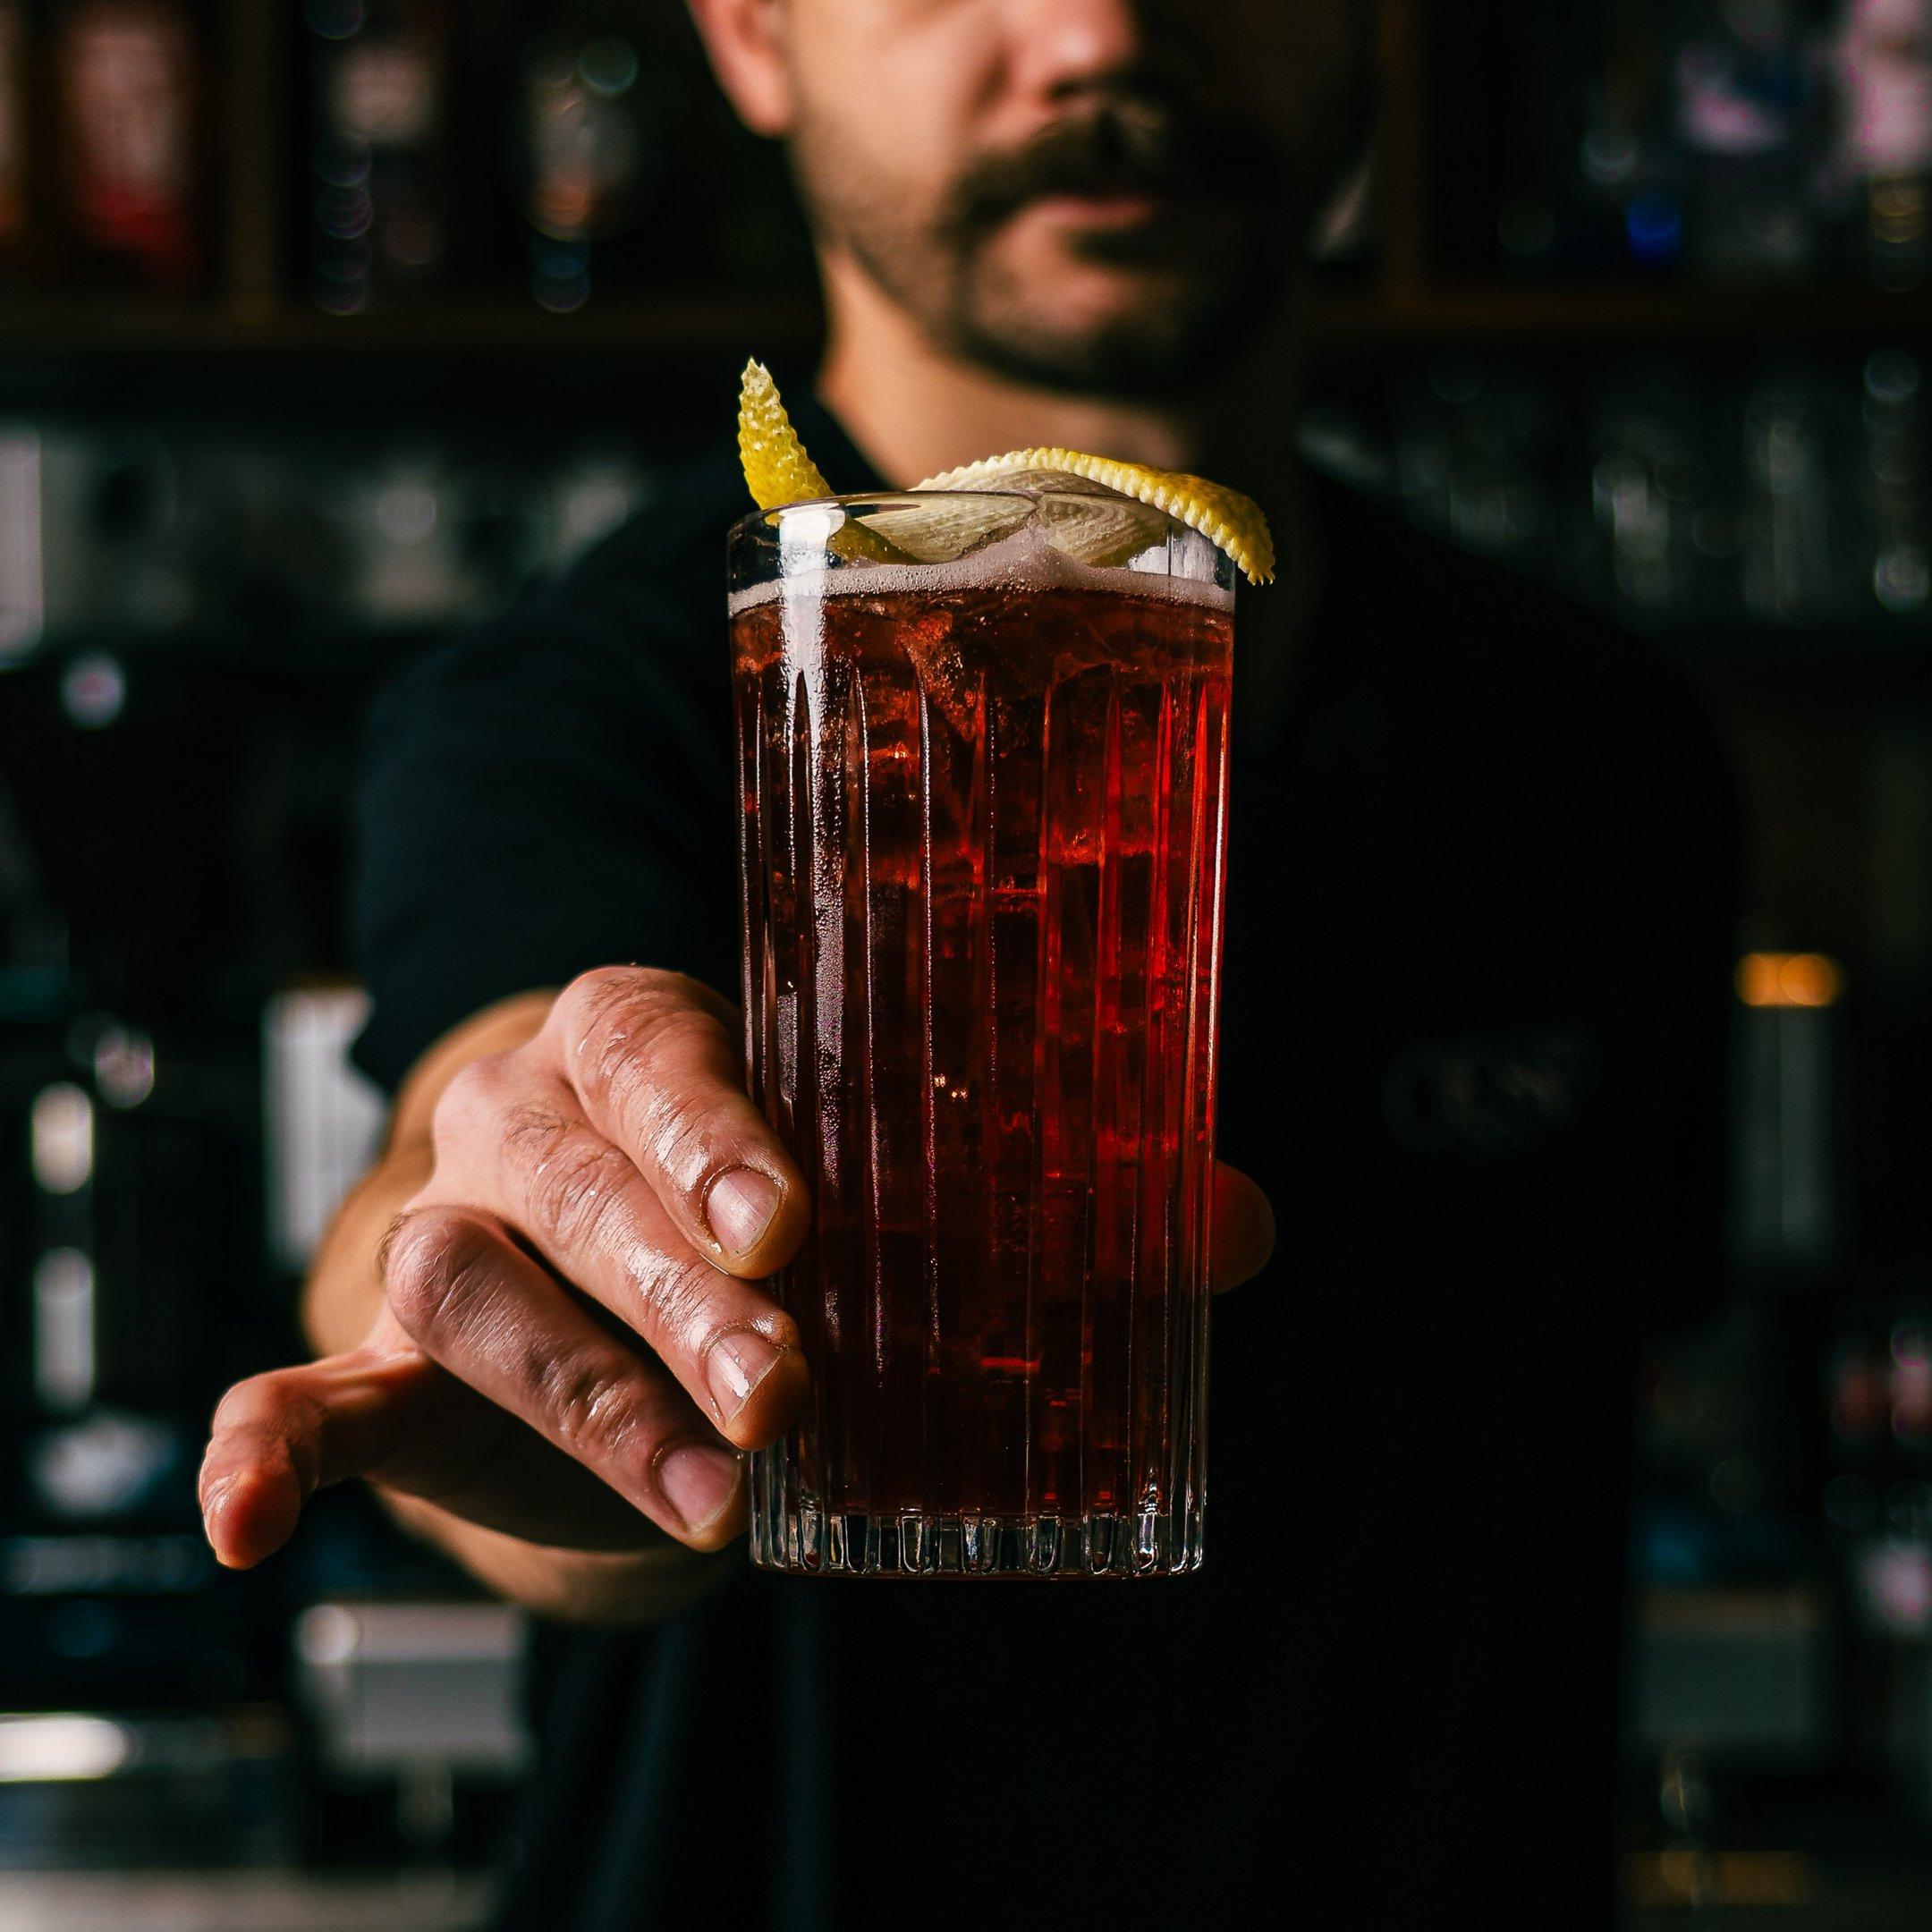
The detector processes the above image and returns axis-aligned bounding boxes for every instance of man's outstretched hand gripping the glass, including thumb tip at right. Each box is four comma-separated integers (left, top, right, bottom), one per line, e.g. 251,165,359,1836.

201,968,1273,1569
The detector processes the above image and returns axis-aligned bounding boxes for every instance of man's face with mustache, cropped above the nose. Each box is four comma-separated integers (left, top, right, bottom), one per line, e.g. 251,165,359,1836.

691,0,1369,390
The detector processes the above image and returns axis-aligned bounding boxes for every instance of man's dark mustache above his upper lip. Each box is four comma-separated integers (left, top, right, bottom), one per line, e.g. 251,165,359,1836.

943,98,1287,236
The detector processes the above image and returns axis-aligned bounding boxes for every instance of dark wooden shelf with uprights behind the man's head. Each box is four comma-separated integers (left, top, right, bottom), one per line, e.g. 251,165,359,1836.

0,0,1932,369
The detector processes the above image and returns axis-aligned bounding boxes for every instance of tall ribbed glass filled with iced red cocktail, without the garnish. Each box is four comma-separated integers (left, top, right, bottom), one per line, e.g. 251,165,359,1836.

733,498,1233,1577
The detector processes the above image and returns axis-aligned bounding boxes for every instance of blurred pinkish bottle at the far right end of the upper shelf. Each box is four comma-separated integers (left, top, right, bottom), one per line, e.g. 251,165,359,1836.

1832,0,1932,290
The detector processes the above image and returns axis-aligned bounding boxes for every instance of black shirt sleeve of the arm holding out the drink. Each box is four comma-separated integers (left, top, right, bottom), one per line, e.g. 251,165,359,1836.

352,558,736,1089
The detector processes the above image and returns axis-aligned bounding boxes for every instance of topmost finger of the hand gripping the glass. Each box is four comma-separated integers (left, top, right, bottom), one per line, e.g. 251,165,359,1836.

547,968,811,1281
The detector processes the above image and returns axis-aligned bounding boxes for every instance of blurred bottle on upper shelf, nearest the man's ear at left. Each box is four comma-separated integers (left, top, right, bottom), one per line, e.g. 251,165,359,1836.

508,0,690,313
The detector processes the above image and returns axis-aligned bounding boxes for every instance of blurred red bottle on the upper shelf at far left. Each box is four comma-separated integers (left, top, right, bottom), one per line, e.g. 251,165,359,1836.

50,0,213,293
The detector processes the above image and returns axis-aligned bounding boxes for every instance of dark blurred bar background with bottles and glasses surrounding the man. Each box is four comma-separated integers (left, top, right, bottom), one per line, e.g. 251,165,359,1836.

0,0,1932,1932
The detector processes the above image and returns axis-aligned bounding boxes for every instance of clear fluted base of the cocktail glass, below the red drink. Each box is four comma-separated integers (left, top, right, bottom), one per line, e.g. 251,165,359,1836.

751,1503,1202,1579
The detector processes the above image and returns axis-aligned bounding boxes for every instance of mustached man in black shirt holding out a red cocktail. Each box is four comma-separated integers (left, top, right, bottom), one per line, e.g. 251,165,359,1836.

203,0,1729,1932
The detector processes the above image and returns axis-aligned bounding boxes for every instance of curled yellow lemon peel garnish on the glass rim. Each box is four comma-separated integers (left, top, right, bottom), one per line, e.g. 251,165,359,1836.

738,361,1275,583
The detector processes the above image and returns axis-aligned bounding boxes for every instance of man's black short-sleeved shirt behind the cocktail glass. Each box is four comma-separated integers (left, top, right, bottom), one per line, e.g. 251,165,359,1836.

360,384,1733,1932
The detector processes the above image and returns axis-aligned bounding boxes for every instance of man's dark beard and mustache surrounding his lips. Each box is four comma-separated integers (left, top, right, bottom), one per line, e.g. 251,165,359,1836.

792,95,1331,396
